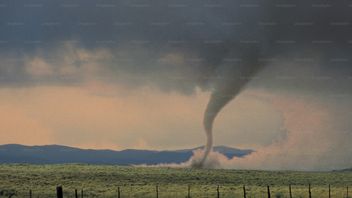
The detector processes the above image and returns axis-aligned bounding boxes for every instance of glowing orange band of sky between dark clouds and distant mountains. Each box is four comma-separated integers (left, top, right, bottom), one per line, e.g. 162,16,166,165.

0,82,281,149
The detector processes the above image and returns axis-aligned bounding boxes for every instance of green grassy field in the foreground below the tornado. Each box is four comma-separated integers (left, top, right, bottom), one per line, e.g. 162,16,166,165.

0,164,352,198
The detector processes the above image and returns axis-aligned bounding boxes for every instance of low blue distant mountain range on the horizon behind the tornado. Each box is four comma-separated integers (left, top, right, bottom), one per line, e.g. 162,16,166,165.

0,144,253,165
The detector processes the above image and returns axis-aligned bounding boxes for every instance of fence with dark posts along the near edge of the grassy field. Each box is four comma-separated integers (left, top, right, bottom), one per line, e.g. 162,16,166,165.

0,184,352,198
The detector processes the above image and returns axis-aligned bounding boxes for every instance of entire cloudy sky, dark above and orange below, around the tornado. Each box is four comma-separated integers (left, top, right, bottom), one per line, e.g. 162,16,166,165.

0,0,352,169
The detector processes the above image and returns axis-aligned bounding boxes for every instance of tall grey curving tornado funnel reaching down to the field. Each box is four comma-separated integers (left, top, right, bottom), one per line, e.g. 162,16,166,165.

197,60,263,168
